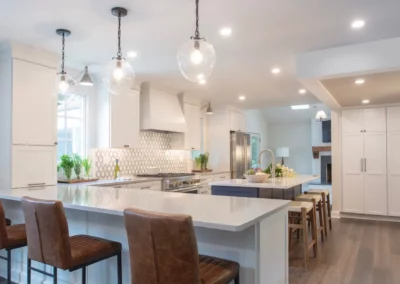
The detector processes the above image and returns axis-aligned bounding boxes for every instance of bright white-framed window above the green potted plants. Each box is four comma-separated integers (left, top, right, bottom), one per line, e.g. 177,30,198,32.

57,95,86,160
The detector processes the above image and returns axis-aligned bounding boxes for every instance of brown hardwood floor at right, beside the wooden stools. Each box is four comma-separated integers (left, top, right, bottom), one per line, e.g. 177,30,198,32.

289,219,400,284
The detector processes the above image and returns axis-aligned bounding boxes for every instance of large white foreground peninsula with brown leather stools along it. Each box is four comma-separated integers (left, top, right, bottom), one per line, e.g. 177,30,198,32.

0,185,289,284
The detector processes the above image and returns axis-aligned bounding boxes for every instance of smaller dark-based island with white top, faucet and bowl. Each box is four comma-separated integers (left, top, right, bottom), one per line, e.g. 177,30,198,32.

209,175,319,200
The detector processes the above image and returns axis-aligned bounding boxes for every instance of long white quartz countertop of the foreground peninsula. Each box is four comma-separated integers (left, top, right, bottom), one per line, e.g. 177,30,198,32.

0,184,289,231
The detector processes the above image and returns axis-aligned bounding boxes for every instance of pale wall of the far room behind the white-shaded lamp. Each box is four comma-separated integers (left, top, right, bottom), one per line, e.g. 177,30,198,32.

267,122,313,174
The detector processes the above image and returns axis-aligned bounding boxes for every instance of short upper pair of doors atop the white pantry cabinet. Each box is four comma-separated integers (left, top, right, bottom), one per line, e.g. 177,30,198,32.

342,107,386,134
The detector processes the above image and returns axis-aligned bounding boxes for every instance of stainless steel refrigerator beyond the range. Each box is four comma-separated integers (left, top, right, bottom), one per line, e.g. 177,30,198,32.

231,131,251,179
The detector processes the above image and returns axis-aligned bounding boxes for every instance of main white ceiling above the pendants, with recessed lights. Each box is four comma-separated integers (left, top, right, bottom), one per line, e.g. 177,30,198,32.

0,0,400,108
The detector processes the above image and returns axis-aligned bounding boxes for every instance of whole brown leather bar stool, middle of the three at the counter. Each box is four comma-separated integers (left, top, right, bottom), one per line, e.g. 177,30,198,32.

22,197,122,284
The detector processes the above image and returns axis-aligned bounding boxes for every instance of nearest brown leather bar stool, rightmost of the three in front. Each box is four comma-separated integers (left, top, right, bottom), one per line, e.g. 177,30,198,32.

124,209,239,284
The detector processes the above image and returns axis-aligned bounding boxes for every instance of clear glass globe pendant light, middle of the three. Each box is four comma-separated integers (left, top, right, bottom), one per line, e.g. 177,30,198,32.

104,7,135,95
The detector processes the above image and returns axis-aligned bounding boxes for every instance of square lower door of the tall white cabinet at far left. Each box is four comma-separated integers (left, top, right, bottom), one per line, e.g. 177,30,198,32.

11,146,57,188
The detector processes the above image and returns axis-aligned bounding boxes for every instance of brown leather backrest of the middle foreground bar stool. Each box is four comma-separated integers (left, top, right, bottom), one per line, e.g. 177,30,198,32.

22,197,71,269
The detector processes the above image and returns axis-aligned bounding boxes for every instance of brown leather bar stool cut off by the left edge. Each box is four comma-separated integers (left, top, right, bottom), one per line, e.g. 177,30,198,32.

0,202,26,284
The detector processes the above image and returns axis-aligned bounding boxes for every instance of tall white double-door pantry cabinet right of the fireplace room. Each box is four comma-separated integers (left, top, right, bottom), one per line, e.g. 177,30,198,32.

342,107,388,215
